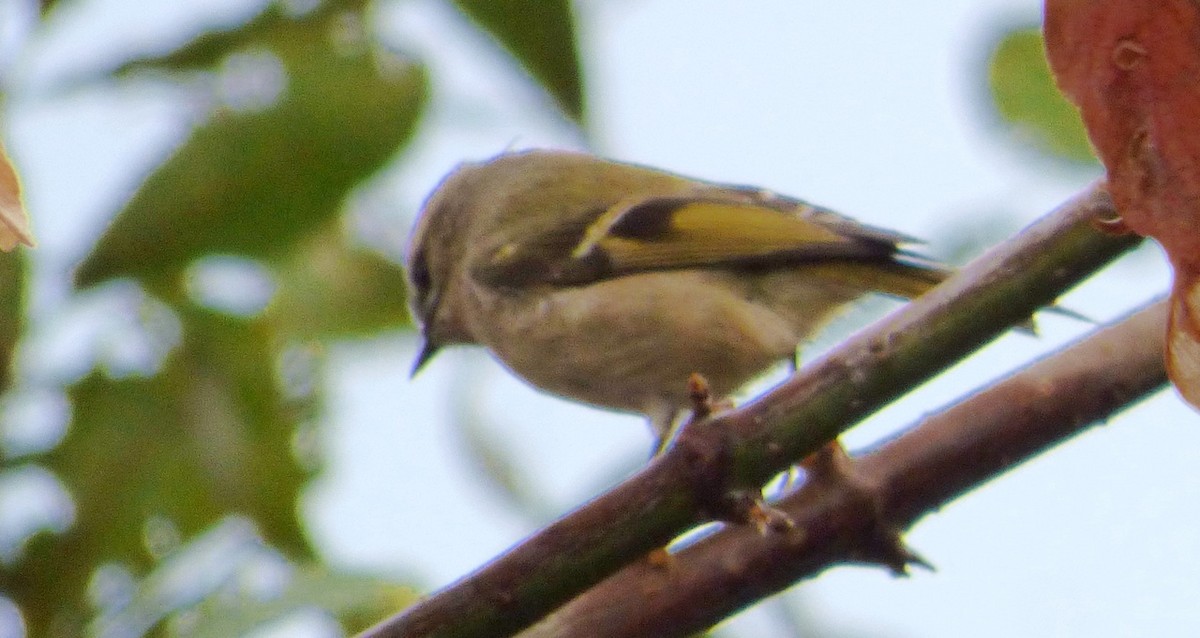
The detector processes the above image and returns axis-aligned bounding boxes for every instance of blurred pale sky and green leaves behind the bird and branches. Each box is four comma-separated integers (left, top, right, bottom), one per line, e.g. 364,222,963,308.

0,0,1200,638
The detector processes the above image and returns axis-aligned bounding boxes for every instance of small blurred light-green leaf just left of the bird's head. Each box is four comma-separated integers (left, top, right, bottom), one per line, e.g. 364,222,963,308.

266,228,410,338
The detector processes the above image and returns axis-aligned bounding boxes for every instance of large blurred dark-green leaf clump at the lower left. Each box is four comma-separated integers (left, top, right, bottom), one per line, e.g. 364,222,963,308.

7,309,316,636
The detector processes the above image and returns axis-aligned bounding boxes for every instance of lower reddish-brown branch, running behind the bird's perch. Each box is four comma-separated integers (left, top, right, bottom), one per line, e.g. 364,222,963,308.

521,301,1166,638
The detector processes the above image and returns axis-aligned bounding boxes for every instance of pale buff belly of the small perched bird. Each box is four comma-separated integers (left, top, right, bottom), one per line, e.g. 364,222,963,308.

475,271,803,413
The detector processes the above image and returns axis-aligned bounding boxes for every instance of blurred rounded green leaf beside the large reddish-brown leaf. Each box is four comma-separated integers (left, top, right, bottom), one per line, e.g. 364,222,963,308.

988,28,1096,163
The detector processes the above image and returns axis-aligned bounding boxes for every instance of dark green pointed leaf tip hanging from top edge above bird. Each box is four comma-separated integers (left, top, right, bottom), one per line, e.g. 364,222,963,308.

455,0,587,124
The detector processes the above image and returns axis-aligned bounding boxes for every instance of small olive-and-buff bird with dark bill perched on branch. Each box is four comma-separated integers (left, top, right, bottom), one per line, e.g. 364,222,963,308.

408,150,949,444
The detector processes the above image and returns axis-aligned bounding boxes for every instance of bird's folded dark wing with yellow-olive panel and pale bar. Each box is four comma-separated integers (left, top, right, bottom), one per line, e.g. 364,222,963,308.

474,192,944,292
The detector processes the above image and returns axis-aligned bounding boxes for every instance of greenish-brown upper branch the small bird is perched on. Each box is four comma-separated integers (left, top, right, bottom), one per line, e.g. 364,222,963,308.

364,187,1136,638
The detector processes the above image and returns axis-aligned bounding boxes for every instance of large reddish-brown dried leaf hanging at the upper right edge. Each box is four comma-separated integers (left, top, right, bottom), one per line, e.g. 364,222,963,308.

1045,0,1200,408
